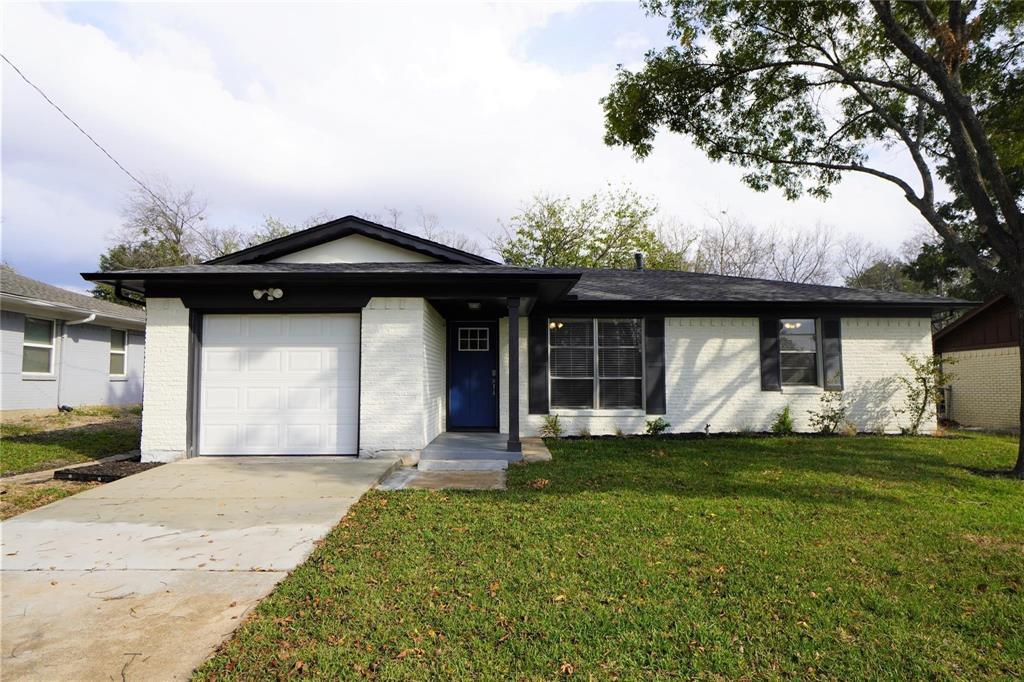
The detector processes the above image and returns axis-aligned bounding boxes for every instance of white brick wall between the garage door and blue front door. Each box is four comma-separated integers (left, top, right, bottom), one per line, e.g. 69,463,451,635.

359,298,444,456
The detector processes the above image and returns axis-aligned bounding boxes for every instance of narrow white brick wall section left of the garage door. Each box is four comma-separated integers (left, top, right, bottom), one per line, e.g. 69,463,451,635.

142,298,188,462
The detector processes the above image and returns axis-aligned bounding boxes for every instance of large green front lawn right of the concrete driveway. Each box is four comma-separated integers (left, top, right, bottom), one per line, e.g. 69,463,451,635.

196,435,1024,680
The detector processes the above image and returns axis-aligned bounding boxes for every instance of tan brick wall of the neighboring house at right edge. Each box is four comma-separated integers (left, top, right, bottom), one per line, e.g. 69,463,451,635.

942,346,1021,429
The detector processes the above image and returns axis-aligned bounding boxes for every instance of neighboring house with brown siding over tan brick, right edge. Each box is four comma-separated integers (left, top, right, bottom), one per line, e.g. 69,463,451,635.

935,296,1021,429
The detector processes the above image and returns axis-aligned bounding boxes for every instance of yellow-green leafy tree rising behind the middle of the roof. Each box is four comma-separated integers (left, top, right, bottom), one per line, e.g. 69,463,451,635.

494,188,683,269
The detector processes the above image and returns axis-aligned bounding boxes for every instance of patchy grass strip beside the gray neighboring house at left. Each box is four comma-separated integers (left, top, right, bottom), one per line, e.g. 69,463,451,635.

0,408,139,476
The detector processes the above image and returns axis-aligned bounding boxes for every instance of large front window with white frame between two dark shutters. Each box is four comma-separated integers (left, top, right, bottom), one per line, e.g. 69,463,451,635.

548,319,643,410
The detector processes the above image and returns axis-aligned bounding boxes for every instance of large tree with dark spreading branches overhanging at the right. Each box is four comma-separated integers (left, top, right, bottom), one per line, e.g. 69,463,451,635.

602,0,1024,478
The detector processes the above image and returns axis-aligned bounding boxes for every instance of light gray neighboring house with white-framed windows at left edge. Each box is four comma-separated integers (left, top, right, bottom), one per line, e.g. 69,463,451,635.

0,265,145,412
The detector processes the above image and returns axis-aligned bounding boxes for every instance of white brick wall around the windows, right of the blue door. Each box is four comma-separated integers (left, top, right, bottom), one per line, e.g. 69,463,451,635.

499,317,935,435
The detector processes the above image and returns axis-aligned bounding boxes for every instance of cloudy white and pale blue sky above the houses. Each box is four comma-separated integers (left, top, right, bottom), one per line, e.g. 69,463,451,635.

0,2,921,288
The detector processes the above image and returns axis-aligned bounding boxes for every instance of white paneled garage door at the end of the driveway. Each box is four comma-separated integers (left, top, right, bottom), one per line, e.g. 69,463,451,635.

199,314,359,455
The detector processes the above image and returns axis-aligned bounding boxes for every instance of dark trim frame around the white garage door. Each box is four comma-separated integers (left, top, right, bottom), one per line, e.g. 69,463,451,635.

185,309,362,458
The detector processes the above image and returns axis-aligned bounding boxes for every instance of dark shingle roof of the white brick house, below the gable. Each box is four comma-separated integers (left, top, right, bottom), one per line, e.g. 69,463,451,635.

84,262,969,307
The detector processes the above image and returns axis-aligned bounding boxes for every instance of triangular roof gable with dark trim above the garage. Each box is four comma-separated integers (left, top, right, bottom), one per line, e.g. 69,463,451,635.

207,215,495,265
